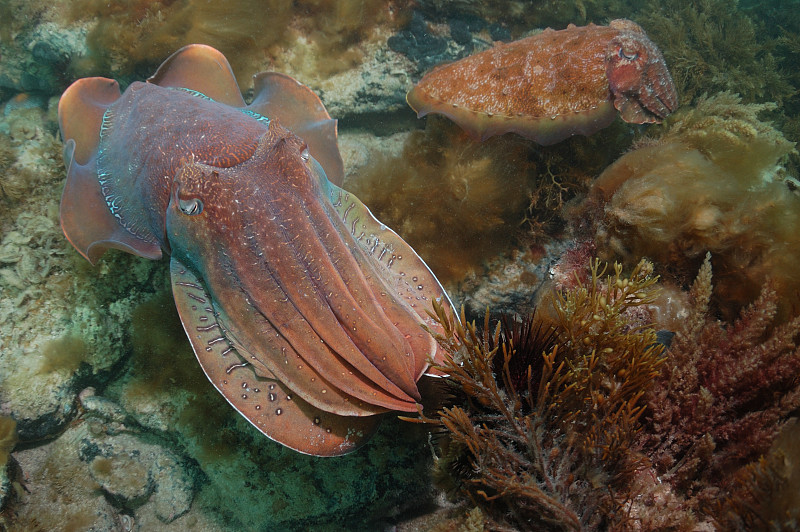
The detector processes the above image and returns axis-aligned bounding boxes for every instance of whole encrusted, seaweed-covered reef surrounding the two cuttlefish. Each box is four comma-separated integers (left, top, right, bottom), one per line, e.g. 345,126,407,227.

0,0,800,531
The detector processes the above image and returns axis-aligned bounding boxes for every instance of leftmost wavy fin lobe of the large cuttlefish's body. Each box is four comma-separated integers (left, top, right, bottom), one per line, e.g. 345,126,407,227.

58,78,161,264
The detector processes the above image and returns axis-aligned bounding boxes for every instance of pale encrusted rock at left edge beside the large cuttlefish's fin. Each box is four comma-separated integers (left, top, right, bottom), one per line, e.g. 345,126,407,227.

0,101,159,441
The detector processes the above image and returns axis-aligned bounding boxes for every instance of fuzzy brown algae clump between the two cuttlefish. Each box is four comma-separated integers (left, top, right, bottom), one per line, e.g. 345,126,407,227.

348,119,536,283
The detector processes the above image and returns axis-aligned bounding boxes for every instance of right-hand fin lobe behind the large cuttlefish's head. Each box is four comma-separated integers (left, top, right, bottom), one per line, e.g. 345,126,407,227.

247,72,344,185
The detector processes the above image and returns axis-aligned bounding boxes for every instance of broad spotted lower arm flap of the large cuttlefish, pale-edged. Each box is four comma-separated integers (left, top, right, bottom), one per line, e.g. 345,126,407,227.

170,256,380,456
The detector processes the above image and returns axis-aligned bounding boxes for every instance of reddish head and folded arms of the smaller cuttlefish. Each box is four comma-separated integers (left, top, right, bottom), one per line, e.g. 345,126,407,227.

606,20,678,124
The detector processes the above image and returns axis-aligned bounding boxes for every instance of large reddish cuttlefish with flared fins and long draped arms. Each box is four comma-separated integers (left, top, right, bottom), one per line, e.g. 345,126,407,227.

58,45,451,456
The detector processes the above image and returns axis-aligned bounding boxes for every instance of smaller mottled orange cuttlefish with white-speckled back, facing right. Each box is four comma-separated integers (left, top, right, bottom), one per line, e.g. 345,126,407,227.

407,19,678,145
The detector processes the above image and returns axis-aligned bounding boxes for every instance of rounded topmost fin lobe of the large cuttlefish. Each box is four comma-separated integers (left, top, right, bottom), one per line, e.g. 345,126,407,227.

147,44,245,107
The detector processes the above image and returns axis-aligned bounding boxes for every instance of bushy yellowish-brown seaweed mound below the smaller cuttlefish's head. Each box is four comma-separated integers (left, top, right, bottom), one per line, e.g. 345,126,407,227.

578,93,800,319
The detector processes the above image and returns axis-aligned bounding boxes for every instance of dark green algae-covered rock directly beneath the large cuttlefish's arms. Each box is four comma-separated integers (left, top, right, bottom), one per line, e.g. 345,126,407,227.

103,292,440,530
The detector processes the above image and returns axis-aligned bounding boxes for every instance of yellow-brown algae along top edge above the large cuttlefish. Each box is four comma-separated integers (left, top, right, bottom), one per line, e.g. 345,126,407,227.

70,0,406,86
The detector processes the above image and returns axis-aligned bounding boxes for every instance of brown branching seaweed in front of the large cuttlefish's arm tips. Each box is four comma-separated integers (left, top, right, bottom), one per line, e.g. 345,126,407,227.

423,261,663,530
